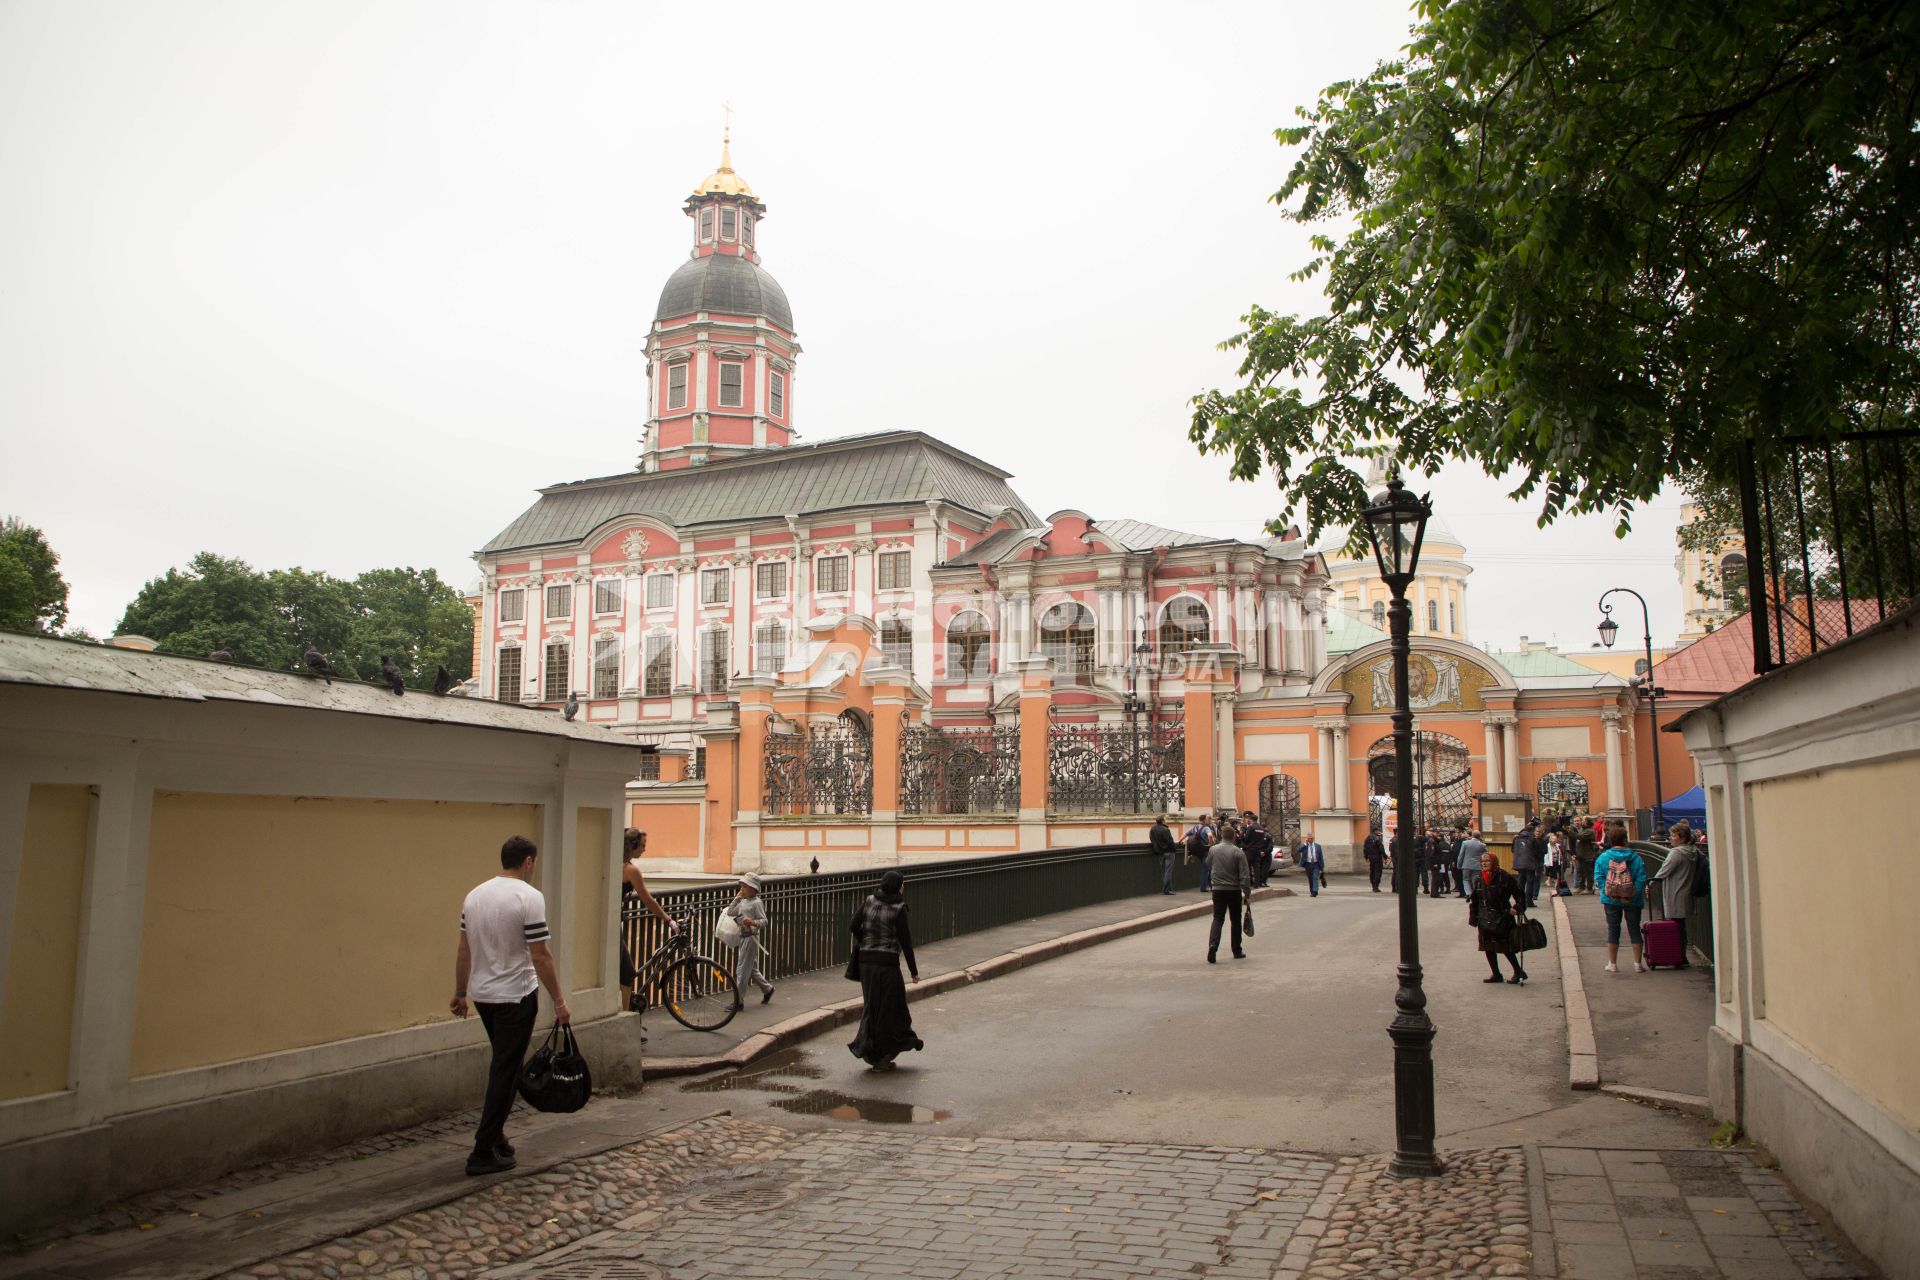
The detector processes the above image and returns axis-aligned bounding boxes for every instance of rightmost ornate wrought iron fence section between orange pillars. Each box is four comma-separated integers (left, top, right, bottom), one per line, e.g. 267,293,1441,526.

1046,718,1187,814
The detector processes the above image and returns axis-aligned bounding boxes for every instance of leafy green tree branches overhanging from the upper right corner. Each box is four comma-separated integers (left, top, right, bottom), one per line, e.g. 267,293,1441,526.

1190,0,1920,533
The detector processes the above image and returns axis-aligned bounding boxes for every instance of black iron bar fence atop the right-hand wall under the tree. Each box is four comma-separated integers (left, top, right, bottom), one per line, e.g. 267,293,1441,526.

1735,430,1920,674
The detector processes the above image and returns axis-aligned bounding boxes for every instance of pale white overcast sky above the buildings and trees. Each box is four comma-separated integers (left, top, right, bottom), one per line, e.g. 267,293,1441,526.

0,0,1680,649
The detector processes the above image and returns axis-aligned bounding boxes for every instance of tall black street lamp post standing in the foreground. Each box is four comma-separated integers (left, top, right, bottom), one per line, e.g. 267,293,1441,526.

1365,480,1446,1178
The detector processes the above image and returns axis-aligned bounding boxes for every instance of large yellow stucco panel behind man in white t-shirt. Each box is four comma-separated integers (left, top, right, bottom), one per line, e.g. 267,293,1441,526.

132,791,541,1077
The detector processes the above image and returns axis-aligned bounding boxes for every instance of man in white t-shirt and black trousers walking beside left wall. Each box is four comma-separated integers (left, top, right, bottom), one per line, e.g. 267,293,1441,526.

447,835,574,1174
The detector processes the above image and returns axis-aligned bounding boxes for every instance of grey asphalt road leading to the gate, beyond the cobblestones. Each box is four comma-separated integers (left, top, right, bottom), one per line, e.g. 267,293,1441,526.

679,881,1705,1153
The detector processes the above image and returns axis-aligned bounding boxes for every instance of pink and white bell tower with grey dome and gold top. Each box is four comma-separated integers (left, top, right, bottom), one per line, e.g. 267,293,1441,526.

639,125,801,470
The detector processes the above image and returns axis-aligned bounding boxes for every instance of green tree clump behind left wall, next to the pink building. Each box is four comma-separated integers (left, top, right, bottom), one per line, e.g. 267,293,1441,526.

119,551,472,689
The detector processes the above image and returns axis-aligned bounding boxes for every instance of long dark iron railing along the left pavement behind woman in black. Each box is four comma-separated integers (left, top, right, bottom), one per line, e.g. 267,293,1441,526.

620,844,1200,979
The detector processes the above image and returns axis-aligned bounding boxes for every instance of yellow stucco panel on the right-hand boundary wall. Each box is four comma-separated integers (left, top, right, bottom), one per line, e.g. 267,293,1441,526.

1747,756,1920,1126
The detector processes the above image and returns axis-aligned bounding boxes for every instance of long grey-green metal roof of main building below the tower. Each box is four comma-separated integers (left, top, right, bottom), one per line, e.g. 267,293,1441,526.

480,432,1035,555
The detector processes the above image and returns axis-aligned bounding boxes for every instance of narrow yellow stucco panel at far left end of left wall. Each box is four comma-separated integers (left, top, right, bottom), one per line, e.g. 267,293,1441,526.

0,787,92,1100
